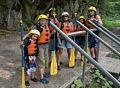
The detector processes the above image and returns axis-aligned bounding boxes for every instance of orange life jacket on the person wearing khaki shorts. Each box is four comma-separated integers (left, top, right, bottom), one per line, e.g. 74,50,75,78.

38,26,50,44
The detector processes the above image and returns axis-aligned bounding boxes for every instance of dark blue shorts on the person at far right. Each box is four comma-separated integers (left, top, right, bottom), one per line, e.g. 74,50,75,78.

88,34,99,48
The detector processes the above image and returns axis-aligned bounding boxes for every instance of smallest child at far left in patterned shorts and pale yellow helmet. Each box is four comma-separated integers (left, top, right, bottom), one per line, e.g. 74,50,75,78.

23,30,40,86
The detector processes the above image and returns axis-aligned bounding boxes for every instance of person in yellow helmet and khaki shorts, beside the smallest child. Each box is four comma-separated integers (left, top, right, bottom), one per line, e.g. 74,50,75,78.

37,14,50,84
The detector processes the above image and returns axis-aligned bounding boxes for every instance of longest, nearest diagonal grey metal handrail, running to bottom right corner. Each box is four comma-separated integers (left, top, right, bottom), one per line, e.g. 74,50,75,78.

49,21,120,87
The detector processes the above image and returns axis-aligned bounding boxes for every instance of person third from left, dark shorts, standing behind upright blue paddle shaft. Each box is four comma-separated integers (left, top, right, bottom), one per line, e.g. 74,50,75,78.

48,8,60,70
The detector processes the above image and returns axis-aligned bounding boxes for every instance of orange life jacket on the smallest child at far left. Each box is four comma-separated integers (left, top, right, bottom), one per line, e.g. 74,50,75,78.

27,40,37,55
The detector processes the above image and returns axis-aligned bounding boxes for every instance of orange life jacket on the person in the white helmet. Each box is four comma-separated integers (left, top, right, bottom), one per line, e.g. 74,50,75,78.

62,22,73,34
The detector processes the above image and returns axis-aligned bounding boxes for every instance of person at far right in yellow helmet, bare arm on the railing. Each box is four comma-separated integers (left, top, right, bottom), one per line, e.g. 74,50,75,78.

86,6,103,60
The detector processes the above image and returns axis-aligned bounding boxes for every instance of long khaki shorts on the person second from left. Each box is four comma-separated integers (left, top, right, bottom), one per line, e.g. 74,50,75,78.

38,48,49,68
